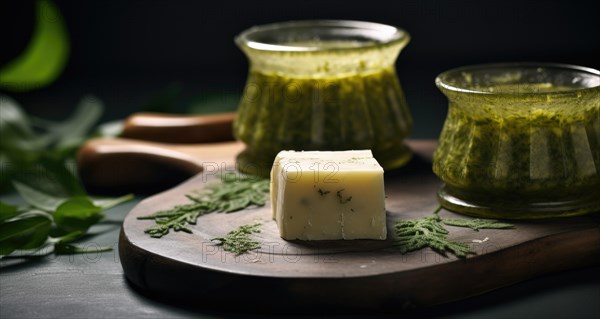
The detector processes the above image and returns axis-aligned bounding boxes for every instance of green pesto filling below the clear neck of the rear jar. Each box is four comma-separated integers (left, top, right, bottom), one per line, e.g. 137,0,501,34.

234,65,412,175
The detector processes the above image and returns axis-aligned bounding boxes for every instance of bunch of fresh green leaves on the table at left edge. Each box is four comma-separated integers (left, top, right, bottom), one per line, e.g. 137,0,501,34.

0,96,133,257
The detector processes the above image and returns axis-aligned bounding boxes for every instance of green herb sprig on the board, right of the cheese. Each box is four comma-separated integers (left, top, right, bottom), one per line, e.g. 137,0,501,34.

394,207,514,258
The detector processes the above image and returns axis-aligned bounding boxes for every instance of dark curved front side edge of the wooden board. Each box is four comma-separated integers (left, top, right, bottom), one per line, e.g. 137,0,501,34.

119,228,600,312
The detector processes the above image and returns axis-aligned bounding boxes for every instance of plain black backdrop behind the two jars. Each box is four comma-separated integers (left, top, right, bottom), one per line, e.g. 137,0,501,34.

0,0,600,138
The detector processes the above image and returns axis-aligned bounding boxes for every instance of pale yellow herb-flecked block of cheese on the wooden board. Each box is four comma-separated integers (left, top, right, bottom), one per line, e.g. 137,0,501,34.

271,150,387,240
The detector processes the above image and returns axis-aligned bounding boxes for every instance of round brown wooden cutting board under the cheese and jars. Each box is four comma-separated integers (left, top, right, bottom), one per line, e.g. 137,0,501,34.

119,141,600,313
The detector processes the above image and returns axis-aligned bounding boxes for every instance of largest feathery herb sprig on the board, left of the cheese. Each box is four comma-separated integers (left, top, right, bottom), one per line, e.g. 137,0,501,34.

138,174,269,238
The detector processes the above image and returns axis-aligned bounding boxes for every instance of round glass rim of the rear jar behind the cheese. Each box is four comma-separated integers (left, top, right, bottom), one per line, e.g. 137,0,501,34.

235,20,410,52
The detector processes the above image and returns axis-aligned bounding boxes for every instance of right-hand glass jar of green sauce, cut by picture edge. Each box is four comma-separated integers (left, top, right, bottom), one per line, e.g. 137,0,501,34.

433,63,600,219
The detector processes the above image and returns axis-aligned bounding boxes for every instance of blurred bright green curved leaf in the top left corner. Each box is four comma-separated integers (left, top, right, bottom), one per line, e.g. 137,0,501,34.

0,0,69,92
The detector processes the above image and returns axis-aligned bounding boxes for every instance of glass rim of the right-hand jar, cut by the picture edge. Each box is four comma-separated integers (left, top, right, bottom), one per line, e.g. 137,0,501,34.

435,62,600,95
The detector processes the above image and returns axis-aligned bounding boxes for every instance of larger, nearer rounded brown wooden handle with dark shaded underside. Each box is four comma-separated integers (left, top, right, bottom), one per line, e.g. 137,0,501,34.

77,138,243,194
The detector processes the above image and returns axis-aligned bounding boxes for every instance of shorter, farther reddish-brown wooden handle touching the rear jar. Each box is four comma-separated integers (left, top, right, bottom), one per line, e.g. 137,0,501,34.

122,112,236,143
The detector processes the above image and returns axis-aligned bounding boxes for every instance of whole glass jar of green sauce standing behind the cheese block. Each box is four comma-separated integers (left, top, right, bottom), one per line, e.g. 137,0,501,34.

234,20,412,176
